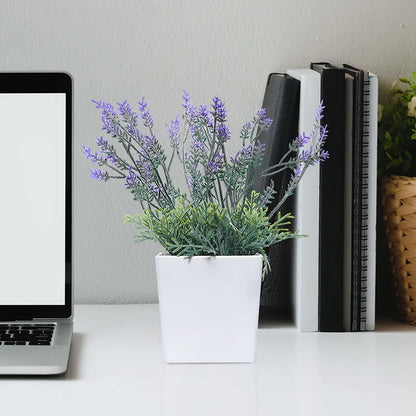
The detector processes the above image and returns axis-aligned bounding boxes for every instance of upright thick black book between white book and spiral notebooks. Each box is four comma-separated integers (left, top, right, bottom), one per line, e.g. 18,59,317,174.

311,62,345,331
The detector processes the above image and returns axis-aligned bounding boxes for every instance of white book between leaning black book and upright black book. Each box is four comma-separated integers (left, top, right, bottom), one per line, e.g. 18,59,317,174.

287,69,321,331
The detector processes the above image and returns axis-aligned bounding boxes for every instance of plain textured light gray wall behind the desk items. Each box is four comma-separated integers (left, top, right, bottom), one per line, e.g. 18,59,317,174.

0,0,416,303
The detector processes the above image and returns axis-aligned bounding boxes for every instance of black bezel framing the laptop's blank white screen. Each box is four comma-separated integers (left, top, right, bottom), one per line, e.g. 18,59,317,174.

0,72,73,321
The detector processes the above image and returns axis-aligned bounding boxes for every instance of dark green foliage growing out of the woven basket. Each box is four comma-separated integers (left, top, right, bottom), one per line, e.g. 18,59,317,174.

378,72,416,176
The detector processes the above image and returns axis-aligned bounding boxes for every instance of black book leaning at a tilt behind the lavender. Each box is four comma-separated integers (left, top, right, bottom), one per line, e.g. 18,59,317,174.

254,73,300,311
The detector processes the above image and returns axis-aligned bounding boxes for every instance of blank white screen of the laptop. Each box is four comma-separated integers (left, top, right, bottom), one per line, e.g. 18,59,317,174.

0,93,66,305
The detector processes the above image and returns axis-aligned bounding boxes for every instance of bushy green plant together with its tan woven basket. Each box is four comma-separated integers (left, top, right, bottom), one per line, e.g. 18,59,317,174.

378,71,416,325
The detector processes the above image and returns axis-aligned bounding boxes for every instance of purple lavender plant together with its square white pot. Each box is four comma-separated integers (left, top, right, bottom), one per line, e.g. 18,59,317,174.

84,91,328,362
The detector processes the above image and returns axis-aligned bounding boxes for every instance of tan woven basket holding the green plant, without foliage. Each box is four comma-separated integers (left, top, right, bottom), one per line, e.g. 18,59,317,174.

381,175,416,325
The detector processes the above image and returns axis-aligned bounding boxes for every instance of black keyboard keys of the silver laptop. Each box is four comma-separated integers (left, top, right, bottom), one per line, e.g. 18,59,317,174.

0,324,56,345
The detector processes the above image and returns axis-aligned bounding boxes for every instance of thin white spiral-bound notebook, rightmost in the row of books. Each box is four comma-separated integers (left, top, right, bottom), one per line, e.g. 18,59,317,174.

366,72,378,331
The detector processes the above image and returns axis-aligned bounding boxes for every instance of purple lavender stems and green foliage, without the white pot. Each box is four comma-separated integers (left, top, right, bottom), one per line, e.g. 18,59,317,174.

83,91,328,271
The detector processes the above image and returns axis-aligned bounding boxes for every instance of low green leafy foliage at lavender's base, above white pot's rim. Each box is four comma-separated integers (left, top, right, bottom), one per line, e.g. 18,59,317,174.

125,192,299,278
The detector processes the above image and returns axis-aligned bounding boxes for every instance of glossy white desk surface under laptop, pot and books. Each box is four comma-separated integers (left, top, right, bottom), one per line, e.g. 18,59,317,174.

0,305,416,416
